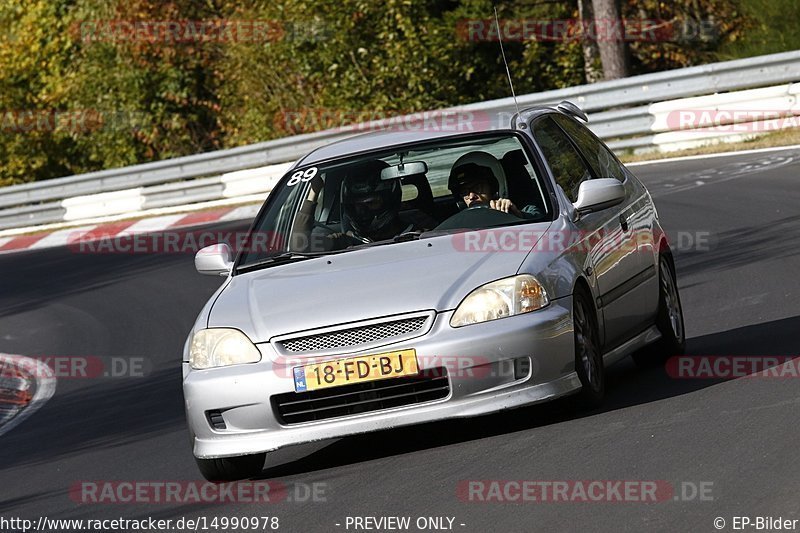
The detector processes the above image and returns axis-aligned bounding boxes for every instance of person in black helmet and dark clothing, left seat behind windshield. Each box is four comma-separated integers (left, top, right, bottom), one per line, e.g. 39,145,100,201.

342,159,403,237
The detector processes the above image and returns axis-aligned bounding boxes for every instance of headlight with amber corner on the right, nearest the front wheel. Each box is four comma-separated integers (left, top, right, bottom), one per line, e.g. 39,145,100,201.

450,274,550,328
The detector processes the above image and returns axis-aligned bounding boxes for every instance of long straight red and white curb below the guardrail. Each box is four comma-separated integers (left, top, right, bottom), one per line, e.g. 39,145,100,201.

0,205,261,254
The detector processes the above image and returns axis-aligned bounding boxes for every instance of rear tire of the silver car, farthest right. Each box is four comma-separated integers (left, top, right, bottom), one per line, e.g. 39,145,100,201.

633,254,686,368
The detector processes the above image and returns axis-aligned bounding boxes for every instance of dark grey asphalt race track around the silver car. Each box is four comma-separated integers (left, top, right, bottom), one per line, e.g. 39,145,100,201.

0,150,800,532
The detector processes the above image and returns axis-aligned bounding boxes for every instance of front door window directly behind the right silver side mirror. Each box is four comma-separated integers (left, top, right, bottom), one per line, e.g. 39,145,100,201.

533,117,592,202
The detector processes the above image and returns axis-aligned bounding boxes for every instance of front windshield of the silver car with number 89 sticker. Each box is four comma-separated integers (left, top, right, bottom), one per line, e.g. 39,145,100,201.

237,133,551,268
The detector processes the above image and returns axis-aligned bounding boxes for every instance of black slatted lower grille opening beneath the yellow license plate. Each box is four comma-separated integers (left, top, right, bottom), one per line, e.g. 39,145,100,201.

272,368,450,425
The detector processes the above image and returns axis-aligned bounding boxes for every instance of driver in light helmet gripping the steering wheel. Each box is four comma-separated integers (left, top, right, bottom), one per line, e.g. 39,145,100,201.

447,163,539,218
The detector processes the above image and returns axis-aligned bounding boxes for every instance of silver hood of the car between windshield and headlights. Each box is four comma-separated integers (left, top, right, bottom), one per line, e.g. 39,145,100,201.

208,222,550,343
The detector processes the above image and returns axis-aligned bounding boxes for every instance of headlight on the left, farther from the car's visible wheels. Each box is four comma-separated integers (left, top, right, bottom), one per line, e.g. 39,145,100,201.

189,328,261,370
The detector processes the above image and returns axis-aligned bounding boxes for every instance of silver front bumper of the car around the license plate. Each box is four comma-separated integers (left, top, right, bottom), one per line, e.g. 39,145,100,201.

183,298,581,459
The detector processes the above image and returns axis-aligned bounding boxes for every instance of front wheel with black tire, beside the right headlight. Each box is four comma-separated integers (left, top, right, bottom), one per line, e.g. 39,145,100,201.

572,288,606,407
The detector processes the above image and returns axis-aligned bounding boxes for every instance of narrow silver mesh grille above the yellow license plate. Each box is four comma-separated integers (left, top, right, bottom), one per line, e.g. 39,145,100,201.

277,315,428,353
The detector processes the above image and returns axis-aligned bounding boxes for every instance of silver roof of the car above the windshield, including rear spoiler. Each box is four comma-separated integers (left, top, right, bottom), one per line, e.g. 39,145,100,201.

296,104,570,166
